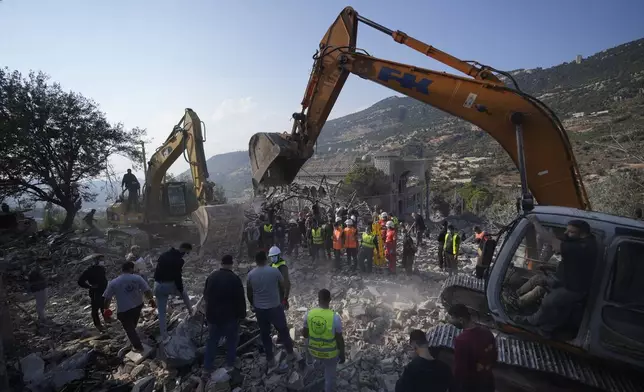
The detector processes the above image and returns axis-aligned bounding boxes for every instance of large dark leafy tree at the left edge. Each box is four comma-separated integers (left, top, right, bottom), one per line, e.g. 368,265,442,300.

0,68,145,230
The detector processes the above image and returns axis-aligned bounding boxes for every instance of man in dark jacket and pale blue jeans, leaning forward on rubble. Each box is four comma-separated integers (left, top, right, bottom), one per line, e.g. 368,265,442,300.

154,242,192,340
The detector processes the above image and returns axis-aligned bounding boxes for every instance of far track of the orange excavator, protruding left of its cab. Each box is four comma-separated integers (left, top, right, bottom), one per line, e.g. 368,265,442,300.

440,274,494,326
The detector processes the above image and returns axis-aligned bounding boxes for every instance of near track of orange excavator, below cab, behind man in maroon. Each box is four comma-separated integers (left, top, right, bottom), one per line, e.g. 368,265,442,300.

427,324,644,392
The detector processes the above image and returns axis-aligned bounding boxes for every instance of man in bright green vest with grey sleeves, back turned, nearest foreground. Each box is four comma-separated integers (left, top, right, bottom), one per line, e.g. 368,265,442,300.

302,289,346,392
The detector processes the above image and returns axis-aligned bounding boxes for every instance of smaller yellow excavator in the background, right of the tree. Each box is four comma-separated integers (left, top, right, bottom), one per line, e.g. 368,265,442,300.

107,108,243,253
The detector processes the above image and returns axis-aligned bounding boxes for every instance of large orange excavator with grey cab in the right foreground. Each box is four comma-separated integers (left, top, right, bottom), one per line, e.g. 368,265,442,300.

249,7,644,392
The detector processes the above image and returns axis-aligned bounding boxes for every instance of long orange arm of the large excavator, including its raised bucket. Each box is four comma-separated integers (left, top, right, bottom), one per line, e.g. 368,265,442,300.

249,7,590,209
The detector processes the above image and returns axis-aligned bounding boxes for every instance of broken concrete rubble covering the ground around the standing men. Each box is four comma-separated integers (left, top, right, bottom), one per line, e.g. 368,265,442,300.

2,224,484,392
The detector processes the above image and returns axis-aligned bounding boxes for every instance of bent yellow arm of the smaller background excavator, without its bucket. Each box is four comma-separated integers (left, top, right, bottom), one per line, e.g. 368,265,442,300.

144,109,213,219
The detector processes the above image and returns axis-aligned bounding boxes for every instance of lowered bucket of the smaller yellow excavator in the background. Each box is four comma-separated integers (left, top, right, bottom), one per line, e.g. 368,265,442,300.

190,204,248,257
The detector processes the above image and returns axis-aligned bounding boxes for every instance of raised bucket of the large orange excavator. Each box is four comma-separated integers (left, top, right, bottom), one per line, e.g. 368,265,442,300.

248,133,310,188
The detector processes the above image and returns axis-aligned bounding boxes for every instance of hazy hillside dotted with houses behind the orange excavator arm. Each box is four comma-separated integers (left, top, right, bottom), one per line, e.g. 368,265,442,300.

196,39,644,197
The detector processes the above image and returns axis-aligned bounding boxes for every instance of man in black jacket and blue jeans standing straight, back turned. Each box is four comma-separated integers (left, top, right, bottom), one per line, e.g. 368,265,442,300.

203,255,246,377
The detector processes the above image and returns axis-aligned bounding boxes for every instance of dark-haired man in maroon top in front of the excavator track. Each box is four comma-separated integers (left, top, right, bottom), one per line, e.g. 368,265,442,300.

448,304,498,392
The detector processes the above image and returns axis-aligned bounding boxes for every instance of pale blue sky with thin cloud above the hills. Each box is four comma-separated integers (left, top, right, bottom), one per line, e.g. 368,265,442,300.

0,0,644,178
